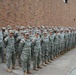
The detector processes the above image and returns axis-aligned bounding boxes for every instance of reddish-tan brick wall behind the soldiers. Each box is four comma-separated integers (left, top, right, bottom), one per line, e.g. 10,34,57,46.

0,0,76,27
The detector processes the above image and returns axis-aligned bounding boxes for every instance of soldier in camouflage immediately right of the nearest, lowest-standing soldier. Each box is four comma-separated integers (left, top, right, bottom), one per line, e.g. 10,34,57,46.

32,30,42,71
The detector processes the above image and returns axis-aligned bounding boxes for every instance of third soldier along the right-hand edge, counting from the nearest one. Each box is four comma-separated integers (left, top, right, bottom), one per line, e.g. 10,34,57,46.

41,30,49,66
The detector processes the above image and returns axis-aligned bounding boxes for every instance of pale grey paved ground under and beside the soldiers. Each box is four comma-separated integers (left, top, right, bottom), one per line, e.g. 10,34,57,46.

0,48,76,75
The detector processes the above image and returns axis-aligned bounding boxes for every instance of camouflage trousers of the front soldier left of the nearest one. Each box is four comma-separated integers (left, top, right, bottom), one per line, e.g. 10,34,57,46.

6,50,16,68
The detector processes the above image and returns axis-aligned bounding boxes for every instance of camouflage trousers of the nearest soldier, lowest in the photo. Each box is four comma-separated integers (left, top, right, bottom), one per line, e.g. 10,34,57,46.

21,54,31,72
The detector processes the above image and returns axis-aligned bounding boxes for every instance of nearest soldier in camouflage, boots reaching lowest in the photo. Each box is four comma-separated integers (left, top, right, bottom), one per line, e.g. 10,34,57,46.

20,32,32,75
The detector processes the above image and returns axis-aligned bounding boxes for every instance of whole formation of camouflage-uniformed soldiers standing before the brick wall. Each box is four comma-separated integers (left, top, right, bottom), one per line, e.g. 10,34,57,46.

0,26,76,75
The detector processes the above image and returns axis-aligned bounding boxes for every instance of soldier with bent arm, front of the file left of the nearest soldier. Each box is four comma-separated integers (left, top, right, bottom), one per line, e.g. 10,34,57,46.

4,30,15,72
